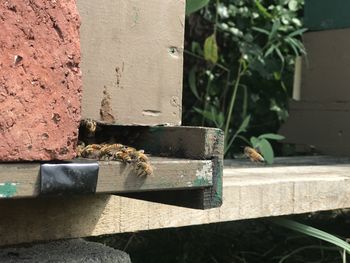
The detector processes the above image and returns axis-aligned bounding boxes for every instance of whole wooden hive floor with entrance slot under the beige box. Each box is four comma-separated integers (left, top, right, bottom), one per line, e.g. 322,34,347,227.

0,126,223,209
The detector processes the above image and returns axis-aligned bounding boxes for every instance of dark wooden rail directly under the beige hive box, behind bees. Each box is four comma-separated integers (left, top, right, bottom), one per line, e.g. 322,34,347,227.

96,125,224,159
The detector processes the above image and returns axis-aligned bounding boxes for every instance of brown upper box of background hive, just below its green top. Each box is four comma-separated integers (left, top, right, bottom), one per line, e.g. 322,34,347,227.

300,28,350,102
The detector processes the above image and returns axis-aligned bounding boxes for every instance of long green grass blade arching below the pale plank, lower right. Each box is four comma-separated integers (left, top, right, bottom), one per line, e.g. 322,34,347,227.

271,218,350,254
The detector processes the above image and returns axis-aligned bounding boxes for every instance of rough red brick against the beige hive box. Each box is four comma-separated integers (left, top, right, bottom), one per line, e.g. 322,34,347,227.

0,0,81,161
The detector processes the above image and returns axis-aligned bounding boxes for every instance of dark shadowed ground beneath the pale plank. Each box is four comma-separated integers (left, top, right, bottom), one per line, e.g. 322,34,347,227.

90,212,350,263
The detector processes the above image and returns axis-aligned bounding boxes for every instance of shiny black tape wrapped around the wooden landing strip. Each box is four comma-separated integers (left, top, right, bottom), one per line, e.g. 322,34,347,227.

40,162,99,196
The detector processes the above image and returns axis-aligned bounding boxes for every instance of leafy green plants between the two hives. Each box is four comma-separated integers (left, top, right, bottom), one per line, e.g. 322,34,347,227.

183,0,305,163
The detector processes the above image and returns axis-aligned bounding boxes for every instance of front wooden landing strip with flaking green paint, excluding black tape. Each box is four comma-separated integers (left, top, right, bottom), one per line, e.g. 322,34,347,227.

0,157,213,198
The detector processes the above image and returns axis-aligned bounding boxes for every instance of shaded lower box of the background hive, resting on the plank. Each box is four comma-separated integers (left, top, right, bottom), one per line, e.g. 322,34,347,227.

279,101,350,155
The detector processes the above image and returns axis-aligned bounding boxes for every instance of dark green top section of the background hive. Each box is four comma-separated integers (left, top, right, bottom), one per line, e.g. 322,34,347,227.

304,0,350,31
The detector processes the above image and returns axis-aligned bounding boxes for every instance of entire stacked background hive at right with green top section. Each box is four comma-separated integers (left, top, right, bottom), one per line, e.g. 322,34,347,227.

280,0,350,155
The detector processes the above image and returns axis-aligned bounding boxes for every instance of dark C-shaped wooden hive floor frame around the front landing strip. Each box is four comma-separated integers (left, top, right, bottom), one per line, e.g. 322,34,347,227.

95,125,224,209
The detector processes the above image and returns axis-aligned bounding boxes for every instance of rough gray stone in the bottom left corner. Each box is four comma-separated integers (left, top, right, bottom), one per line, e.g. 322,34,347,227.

0,239,131,263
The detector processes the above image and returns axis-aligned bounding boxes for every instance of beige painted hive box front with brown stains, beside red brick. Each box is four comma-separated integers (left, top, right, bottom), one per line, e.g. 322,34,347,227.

77,0,185,125
